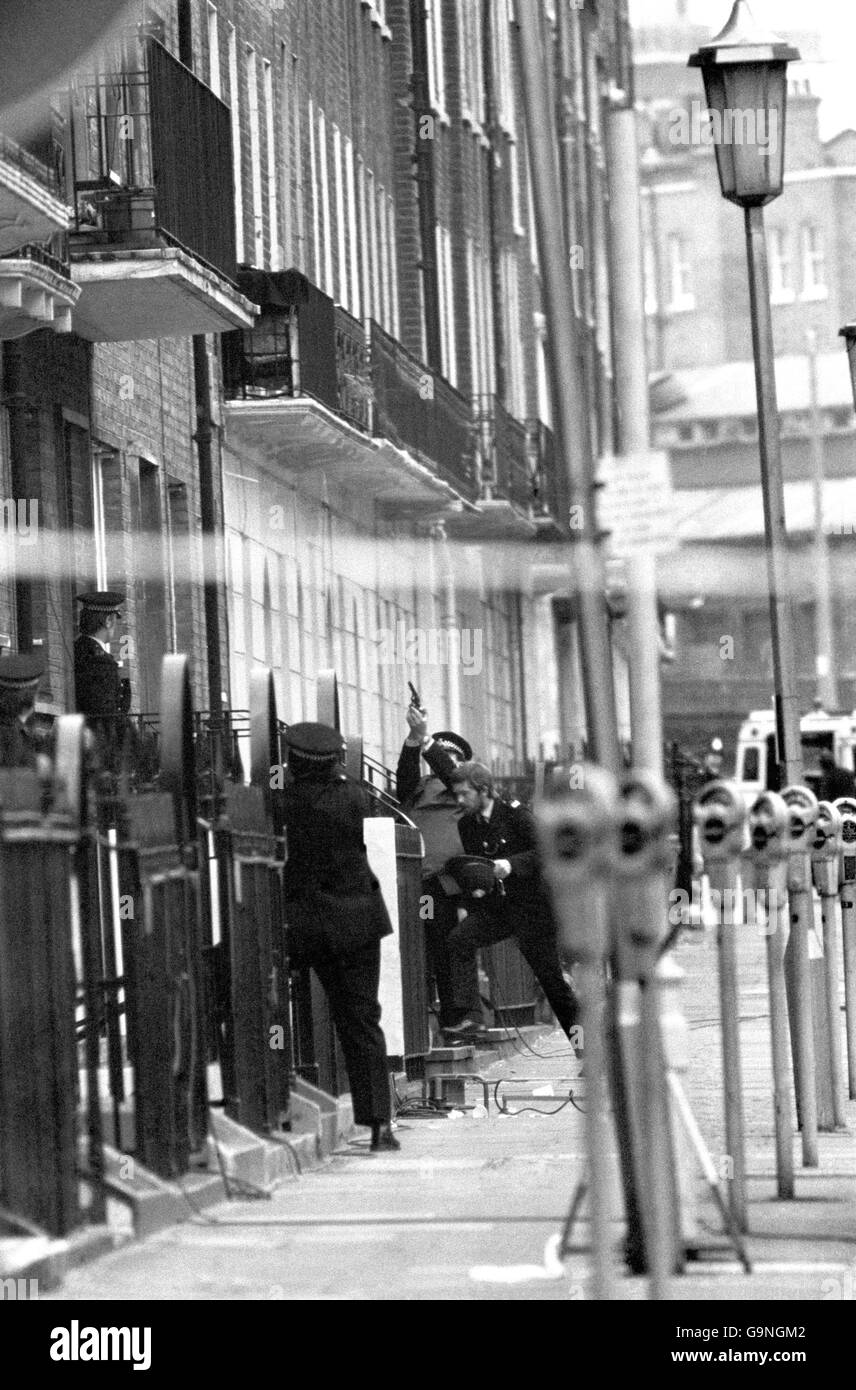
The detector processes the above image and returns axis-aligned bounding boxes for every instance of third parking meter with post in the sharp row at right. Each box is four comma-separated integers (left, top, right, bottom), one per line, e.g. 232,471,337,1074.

782,787,818,1168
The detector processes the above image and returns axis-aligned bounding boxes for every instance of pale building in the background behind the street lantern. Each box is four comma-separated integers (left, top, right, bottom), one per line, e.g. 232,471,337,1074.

634,4,856,752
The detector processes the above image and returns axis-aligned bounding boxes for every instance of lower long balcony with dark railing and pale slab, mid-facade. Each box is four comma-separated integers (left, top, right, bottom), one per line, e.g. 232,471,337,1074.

224,270,474,513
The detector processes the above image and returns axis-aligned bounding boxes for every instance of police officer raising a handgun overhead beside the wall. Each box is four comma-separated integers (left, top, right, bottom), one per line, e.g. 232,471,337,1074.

396,705,482,1033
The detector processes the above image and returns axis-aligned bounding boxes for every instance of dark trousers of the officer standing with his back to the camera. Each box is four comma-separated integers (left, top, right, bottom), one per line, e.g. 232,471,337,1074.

311,941,392,1125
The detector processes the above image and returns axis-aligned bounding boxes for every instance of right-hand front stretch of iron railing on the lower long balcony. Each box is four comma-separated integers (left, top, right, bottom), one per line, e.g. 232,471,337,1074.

370,320,478,500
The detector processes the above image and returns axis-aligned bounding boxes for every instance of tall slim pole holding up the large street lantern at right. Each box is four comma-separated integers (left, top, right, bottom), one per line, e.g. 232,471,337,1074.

745,207,803,787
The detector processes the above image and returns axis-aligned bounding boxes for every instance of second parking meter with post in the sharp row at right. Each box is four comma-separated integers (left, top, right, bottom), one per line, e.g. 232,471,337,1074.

748,792,795,1198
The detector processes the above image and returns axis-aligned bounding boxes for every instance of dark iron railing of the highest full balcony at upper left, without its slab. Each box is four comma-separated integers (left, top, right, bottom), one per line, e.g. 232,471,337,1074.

69,36,238,281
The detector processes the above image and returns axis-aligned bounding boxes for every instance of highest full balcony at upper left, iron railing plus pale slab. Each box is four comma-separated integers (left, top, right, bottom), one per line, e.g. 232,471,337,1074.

69,38,254,342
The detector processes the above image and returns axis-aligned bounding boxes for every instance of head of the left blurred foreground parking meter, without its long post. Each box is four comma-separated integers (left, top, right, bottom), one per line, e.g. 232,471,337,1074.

534,763,618,960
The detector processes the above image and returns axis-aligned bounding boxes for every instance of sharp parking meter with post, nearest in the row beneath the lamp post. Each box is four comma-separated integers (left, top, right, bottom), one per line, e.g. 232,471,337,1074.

695,781,748,1232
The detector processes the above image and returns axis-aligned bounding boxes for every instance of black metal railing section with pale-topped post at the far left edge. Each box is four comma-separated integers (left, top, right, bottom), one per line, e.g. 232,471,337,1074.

0,716,101,1236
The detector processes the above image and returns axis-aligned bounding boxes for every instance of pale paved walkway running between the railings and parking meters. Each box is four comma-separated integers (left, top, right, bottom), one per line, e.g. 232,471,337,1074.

43,927,856,1301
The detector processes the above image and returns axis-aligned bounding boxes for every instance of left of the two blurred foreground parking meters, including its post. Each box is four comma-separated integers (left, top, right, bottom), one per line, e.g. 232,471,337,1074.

535,765,617,1300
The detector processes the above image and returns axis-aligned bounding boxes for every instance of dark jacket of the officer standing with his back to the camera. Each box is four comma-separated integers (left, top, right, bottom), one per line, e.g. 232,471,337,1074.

281,774,392,963
